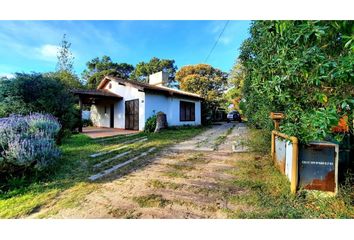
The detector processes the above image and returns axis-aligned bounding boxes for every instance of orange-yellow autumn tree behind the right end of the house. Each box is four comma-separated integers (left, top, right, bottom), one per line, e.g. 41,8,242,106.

176,64,227,124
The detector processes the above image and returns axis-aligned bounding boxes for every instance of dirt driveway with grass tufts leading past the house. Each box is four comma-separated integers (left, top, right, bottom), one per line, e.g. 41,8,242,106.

38,123,247,218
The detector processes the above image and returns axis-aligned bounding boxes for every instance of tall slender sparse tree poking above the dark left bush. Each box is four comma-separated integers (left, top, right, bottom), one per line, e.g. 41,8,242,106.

53,34,82,89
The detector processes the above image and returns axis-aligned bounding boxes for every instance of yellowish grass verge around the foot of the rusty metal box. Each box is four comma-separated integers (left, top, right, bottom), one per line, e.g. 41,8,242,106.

225,130,354,218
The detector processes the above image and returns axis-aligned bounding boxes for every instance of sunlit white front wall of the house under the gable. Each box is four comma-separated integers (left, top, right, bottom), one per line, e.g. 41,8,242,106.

91,81,145,130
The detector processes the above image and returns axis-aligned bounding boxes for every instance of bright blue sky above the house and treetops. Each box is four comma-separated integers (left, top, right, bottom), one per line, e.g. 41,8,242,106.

0,21,250,76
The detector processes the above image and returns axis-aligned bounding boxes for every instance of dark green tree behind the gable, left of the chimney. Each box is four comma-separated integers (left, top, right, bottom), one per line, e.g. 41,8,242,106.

82,56,134,89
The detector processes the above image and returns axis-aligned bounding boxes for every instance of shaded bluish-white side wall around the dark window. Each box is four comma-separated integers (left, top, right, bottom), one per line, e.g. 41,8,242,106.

145,93,201,126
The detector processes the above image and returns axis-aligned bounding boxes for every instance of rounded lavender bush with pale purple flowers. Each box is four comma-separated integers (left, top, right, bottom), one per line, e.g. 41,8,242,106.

0,113,61,173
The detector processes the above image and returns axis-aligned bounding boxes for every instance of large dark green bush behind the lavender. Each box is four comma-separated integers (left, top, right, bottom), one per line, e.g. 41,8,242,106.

0,73,80,139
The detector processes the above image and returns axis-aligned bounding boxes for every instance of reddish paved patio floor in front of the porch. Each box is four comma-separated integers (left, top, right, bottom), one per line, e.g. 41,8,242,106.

82,127,139,138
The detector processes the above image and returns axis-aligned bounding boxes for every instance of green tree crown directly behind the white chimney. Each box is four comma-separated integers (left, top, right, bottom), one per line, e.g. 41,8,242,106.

130,57,177,87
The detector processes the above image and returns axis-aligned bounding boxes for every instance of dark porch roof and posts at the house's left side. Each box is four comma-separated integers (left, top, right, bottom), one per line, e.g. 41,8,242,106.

73,89,123,132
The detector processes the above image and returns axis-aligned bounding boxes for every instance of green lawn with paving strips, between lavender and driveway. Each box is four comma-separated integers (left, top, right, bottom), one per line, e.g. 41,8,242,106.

0,127,205,218
